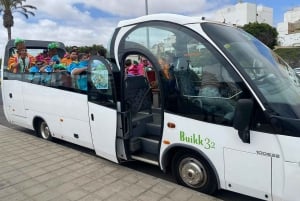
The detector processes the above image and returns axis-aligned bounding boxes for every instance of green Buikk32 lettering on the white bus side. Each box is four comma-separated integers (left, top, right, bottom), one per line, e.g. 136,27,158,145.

179,131,215,149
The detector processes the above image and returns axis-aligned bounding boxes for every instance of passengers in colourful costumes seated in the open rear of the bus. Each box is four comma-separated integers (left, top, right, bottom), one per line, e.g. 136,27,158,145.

8,39,89,75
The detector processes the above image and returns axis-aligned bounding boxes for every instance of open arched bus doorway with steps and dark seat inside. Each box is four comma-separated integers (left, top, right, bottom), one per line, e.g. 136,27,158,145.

118,50,163,166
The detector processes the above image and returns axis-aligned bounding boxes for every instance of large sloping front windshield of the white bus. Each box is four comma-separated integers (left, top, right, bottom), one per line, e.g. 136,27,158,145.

202,23,300,119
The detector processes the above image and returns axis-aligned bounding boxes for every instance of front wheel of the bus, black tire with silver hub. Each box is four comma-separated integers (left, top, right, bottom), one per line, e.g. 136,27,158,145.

172,152,218,195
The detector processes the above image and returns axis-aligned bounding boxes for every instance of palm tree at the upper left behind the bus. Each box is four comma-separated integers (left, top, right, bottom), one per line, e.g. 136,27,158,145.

0,0,36,40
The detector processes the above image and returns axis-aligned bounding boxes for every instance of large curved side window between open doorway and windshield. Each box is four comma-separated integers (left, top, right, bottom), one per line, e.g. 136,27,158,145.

125,24,242,125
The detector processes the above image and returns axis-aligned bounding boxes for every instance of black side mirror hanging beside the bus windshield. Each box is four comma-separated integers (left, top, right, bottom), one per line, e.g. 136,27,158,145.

233,99,253,143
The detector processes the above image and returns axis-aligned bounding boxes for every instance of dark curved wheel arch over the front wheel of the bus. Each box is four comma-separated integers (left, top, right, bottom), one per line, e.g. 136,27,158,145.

160,144,221,189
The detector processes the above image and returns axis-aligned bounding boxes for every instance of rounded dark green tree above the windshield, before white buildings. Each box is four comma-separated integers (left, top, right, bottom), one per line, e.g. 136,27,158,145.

242,22,278,49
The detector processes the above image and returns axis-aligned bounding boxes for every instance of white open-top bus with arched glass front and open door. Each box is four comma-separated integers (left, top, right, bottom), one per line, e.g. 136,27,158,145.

1,14,300,201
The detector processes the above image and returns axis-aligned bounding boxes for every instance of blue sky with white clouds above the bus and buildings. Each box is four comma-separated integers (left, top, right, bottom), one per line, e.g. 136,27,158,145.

0,0,300,58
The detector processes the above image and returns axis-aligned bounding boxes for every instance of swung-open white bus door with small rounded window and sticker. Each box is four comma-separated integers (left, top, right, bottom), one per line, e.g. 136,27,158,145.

87,56,118,162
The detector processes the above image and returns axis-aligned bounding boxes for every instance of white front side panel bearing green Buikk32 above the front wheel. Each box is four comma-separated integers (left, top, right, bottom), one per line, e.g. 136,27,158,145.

160,113,281,200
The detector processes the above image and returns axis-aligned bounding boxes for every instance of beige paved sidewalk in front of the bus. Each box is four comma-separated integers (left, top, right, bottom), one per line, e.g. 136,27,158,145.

0,125,220,201
